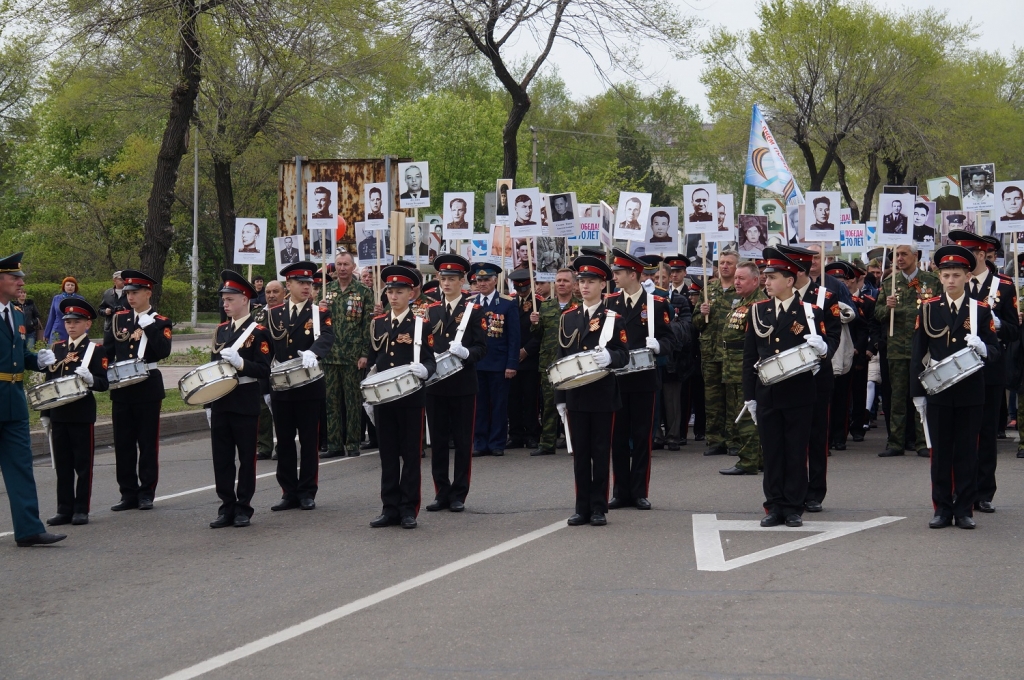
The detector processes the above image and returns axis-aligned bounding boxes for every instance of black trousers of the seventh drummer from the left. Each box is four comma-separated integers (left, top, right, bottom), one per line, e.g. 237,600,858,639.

568,411,615,517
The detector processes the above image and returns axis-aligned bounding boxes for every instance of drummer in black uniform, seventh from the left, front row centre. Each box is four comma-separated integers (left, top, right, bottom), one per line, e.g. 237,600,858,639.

555,255,629,526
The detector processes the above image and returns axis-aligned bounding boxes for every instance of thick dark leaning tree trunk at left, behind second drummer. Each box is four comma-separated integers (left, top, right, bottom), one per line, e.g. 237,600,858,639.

139,0,202,306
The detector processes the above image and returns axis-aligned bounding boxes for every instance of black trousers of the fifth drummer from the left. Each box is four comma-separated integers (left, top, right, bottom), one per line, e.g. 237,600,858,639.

374,396,421,519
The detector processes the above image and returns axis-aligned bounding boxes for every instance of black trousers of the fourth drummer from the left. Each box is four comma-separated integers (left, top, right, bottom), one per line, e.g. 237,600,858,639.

270,392,323,501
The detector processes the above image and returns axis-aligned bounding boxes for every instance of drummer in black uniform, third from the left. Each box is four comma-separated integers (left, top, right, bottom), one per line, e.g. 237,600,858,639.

206,269,273,528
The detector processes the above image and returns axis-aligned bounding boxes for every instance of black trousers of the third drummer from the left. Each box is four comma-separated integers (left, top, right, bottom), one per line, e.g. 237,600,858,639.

210,411,259,517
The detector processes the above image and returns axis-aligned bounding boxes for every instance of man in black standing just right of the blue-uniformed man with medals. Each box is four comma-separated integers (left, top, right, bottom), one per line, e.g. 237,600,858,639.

505,269,544,450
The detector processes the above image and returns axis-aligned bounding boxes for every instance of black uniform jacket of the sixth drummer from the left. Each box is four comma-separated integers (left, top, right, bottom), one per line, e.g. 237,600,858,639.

424,295,487,396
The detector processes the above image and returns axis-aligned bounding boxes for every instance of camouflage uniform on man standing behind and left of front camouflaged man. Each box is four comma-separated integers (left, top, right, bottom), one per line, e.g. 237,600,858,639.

693,279,739,450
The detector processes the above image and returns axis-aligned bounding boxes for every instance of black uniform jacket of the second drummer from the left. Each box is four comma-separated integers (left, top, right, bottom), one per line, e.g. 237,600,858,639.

103,309,171,402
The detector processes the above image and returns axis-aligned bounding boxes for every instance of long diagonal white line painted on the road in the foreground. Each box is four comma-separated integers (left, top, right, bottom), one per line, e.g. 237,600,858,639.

161,519,567,680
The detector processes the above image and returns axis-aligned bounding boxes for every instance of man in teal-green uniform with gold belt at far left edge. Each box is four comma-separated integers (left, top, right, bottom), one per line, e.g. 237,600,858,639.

0,253,68,548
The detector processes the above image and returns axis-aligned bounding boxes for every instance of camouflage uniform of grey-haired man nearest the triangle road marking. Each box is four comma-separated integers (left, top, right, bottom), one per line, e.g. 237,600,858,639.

722,288,765,472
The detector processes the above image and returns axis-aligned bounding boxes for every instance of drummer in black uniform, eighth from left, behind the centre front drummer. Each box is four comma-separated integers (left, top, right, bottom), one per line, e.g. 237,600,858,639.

605,248,672,510
